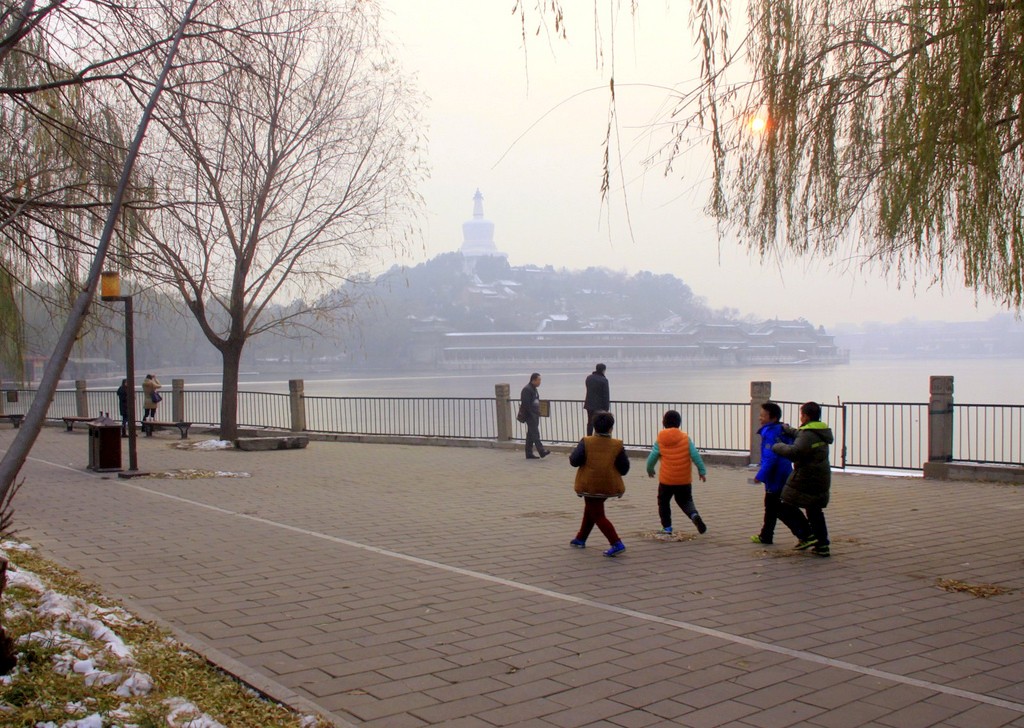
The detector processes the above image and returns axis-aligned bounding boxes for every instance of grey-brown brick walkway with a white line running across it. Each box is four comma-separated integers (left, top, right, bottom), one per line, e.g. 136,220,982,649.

6,428,1024,728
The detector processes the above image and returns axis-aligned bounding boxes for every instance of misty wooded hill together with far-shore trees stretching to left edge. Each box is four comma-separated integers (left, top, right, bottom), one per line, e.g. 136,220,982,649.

0,252,835,381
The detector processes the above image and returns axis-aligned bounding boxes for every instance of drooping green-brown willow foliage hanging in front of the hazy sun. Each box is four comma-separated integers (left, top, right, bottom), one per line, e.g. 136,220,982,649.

674,0,1024,309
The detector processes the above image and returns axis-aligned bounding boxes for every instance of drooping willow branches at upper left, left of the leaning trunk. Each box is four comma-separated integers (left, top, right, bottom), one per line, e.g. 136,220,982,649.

0,0,152,372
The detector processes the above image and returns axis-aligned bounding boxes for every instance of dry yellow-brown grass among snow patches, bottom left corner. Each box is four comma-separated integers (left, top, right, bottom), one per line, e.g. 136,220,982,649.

0,549,330,728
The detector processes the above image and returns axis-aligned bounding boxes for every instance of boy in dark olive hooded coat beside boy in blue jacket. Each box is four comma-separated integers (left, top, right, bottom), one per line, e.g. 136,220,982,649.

772,401,835,556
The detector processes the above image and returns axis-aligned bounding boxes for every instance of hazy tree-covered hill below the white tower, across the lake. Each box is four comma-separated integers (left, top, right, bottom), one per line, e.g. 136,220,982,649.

260,253,761,369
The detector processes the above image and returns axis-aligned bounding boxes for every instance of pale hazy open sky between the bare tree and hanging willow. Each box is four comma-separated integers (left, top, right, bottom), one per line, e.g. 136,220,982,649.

381,0,1004,326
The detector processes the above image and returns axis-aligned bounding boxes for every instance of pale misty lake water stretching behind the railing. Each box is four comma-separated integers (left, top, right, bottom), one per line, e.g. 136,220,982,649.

186,359,1024,404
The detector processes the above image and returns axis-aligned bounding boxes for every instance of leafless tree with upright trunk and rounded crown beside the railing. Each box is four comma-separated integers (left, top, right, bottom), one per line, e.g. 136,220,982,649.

139,0,420,438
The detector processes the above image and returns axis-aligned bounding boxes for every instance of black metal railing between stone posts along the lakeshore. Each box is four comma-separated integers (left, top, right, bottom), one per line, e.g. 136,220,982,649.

6,389,1024,470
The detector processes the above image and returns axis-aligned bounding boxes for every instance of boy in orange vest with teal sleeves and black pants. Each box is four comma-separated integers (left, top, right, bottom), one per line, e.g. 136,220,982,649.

647,410,708,533
